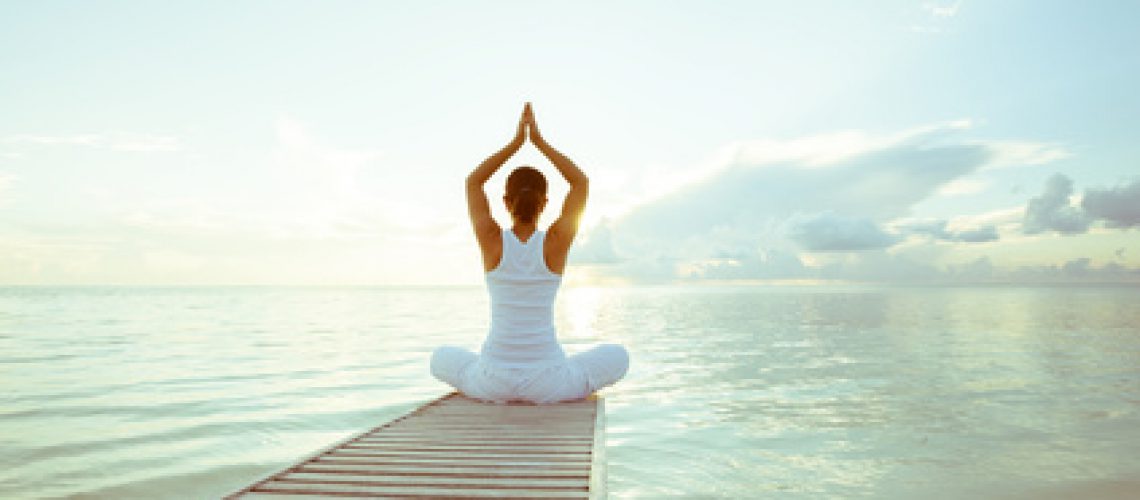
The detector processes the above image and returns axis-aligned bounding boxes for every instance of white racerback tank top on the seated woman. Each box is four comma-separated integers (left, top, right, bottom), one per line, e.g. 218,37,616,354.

481,229,565,368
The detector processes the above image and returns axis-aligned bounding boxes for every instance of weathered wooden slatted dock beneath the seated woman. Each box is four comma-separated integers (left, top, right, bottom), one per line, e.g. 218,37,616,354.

227,393,605,500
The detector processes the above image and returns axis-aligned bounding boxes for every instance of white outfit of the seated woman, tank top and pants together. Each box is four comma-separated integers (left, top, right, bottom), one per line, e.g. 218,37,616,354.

431,229,629,403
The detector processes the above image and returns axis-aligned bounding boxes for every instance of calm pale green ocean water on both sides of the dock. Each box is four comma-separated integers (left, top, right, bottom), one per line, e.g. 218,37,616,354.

0,286,1140,499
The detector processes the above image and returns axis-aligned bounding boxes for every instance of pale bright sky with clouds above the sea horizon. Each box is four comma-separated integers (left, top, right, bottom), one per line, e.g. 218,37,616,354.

0,1,1140,285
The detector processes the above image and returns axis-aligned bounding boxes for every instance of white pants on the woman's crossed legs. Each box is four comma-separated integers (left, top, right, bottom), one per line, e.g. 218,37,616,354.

431,344,629,403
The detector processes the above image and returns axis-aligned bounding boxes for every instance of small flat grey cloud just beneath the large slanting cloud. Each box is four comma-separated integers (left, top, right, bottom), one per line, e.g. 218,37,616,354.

788,213,898,252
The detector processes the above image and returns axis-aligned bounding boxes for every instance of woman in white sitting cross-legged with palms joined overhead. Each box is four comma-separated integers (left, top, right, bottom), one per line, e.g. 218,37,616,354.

431,103,629,403
